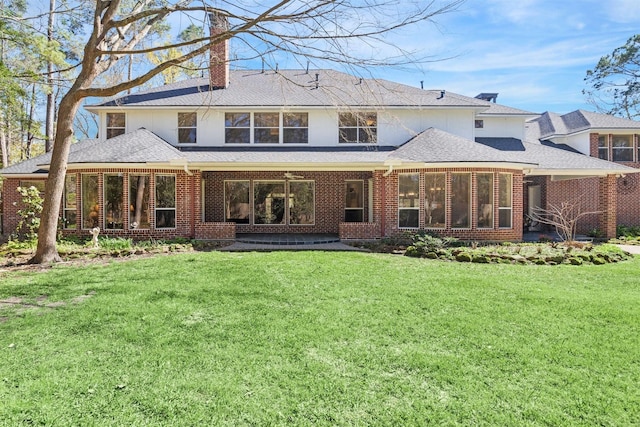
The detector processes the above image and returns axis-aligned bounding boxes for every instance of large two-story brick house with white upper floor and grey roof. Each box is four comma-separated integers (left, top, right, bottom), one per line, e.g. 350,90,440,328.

0,26,640,240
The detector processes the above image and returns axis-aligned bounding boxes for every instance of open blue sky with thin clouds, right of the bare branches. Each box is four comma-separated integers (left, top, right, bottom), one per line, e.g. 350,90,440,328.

375,0,640,113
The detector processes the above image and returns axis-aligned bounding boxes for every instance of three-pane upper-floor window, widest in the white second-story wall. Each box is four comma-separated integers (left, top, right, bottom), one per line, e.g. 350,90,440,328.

224,112,309,144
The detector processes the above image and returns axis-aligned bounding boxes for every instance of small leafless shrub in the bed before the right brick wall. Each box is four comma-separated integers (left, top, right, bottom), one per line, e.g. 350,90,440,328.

530,198,601,242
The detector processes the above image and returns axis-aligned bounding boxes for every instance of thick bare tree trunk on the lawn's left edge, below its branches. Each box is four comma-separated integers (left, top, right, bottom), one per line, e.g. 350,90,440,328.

29,92,82,264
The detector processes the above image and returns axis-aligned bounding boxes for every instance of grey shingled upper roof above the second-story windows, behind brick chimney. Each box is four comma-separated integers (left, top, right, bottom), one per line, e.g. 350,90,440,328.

87,70,489,111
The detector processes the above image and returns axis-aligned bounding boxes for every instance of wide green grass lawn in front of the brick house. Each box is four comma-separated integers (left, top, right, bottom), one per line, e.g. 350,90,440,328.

0,252,640,426
